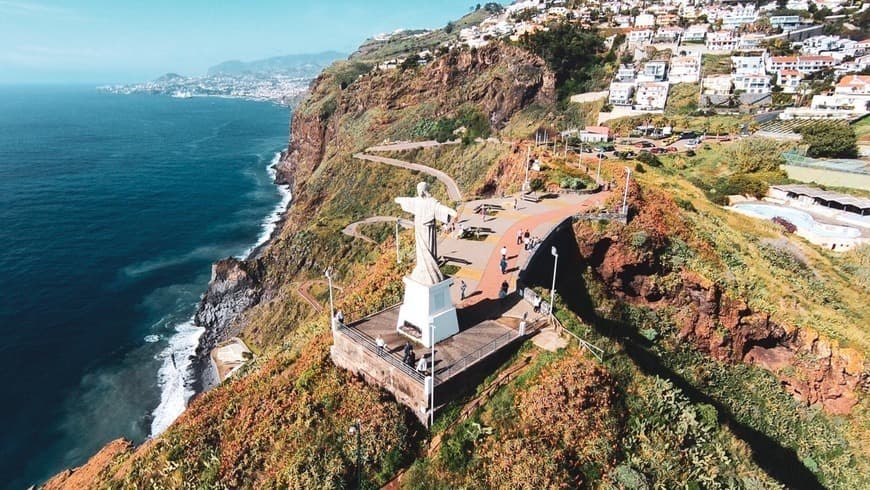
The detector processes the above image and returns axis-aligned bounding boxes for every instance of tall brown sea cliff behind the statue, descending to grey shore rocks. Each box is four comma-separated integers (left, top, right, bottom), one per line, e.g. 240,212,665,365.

196,41,555,351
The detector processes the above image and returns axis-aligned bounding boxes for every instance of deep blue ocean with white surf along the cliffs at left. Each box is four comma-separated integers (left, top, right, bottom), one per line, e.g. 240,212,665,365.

0,86,290,489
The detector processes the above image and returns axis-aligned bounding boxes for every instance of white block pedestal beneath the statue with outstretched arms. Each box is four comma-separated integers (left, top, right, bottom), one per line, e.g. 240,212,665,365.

396,276,459,347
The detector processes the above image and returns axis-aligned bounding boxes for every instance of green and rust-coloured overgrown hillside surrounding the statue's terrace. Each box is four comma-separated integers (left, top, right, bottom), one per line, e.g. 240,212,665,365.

48,21,870,489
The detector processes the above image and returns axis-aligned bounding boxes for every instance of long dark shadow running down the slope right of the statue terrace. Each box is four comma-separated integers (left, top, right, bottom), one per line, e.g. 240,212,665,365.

525,227,823,489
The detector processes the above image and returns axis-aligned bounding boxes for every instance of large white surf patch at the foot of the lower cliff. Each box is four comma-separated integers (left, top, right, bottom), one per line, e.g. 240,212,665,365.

151,319,205,437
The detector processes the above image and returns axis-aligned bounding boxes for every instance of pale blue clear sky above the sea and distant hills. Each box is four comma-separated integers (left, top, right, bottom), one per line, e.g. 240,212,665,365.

0,0,484,84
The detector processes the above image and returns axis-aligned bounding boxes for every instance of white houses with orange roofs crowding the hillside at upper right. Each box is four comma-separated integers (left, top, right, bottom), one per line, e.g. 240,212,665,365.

380,0,870,126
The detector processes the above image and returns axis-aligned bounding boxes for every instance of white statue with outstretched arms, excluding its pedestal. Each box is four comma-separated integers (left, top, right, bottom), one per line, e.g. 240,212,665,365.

396,182,456,286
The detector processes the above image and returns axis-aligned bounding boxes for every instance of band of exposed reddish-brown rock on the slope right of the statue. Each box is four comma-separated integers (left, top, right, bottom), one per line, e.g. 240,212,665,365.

576,226,864,414
